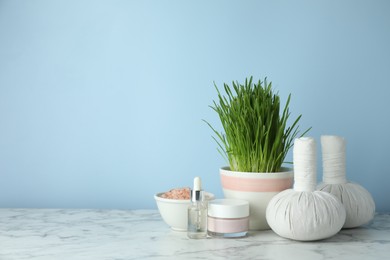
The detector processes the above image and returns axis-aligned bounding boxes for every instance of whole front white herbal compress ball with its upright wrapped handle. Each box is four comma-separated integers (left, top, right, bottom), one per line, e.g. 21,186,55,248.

266,137,346,241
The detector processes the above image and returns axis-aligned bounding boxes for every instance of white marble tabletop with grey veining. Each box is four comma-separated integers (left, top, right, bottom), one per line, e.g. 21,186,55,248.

0,209,390,260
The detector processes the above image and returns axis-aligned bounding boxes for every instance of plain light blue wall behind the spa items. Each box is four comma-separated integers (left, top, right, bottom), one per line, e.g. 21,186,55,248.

0,0,390,211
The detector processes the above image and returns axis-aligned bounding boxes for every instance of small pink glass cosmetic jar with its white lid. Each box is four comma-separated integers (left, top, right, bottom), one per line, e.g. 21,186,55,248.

207,199,249,238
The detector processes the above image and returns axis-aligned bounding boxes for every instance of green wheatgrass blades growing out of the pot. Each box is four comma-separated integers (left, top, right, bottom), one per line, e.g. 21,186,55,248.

205,77,310,172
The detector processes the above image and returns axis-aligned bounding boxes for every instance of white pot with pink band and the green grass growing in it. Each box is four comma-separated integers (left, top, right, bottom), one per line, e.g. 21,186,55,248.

206,77,309,230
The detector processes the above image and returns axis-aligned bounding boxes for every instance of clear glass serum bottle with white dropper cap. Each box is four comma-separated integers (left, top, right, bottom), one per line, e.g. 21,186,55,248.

187,177,207,239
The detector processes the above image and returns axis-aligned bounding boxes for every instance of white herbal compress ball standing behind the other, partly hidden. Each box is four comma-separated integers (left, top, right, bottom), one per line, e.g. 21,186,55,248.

317,136,375,228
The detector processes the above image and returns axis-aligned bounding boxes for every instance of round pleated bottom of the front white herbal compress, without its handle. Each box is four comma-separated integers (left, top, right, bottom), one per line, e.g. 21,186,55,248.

267,189,345,241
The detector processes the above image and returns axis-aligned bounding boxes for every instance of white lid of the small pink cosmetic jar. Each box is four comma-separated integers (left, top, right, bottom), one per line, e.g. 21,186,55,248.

207,199,249,218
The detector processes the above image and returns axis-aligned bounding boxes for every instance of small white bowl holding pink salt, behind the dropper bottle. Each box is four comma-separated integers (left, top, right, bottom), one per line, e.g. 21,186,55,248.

154,192,214,231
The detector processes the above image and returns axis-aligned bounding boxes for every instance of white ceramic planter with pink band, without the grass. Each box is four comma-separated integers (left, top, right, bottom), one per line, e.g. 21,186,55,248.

220,167,294,230
